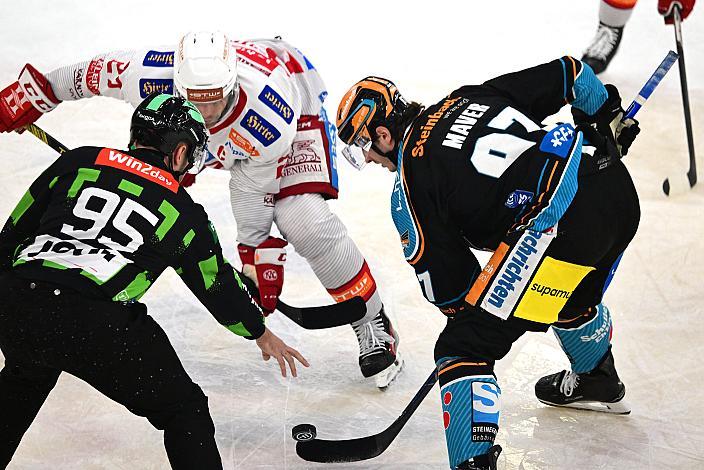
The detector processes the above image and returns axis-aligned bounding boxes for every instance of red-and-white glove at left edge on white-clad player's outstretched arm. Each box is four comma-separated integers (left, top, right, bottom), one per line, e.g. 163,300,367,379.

0,64,61,132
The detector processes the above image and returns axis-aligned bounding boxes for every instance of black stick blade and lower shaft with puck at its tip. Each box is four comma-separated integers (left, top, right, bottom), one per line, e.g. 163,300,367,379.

296,369,438,463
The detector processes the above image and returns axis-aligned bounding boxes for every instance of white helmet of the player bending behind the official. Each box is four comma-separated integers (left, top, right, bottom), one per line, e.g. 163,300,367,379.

174,32,239,104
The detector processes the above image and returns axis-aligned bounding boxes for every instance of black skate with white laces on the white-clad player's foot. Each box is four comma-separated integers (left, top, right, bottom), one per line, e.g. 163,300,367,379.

352,306,403,389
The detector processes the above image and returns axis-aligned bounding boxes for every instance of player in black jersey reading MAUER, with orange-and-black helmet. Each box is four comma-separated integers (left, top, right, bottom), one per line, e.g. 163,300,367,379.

337,57,640,469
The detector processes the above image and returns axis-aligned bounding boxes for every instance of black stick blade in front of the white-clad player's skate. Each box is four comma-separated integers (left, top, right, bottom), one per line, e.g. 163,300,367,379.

276,297,367,330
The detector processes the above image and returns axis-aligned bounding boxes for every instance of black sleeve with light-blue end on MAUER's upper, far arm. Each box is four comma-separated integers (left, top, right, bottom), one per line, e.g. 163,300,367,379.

484,56,608,121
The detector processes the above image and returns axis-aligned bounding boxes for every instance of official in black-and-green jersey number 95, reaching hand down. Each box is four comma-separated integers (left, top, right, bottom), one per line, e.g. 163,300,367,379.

0,94,308,469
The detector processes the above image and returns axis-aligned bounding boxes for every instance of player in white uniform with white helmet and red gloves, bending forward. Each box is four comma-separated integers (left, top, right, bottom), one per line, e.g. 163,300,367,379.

0,32,402,388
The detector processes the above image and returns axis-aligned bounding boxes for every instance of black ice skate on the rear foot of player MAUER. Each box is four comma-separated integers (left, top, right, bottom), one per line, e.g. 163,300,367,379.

535,348,631,414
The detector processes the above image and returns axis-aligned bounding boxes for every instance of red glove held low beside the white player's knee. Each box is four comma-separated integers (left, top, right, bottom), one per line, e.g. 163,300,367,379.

237,237,288,315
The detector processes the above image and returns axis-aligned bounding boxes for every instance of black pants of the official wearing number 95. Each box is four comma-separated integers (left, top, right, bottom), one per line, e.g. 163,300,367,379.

0,274,222,469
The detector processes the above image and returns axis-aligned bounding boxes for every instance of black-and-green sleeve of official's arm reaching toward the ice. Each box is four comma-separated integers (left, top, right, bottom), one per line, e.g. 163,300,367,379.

176,206,264,339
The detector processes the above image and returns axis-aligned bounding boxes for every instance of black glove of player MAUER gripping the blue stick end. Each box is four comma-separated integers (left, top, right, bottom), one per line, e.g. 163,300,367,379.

572,85,640,159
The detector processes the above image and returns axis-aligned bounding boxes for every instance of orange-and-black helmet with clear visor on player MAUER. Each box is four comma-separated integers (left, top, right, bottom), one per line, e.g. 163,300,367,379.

336,76,412,168
